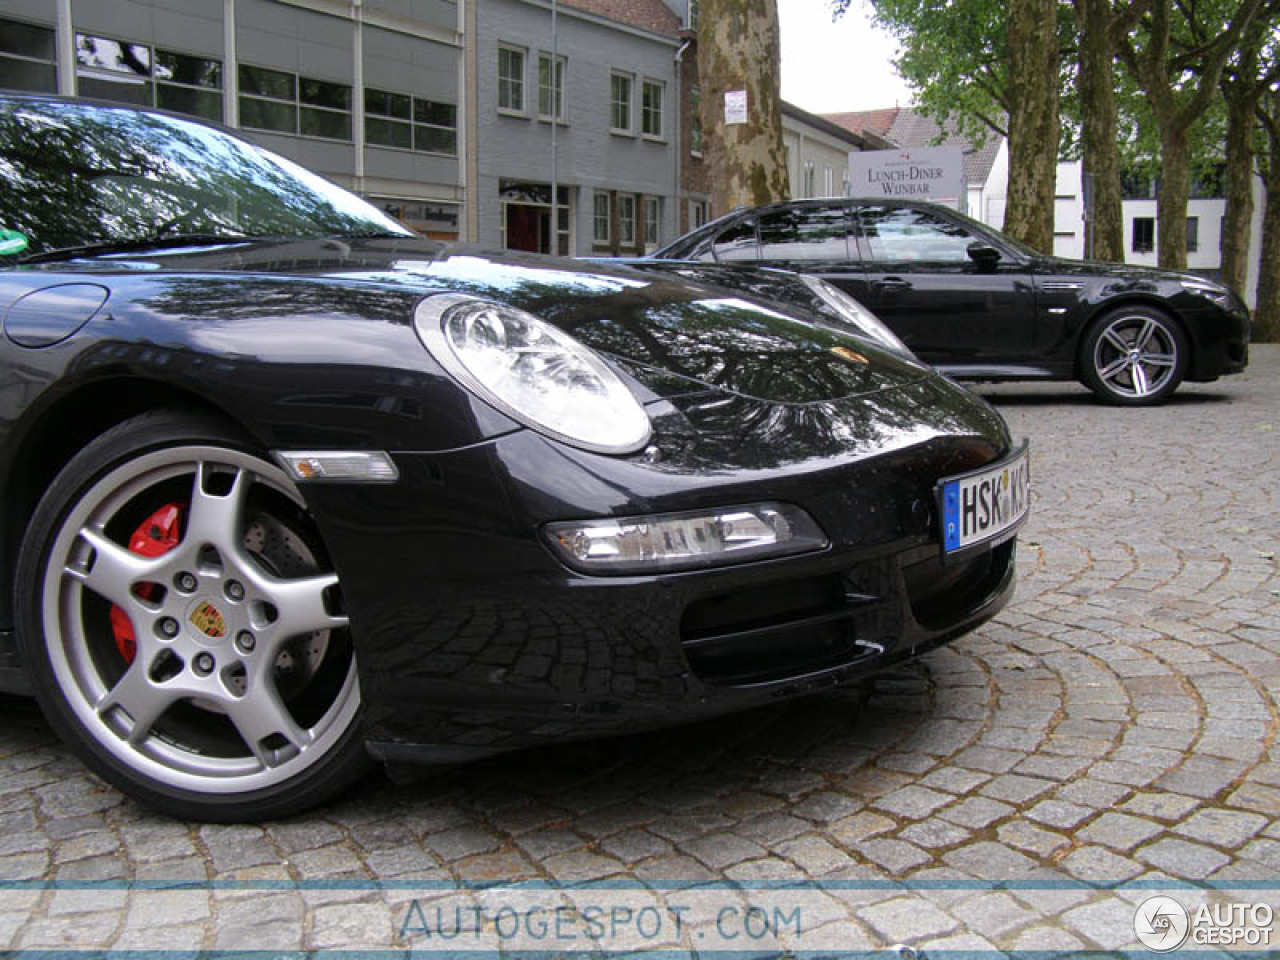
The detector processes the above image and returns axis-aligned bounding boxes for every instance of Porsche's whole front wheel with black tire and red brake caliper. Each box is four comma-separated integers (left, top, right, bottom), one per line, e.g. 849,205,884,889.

17,411,369,822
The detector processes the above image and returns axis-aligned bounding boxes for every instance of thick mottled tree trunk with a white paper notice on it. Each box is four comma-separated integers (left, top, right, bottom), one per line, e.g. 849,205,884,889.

698,0,791,215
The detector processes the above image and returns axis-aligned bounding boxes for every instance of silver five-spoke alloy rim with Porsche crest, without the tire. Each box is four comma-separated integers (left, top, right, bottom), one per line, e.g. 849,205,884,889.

41,445,360,795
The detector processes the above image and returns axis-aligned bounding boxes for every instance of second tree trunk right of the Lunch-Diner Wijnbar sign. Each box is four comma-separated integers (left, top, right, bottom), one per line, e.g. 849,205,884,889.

1075,0,1124,262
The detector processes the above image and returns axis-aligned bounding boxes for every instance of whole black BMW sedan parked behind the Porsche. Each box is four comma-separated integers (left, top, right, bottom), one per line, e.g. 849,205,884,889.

654,198,1249,406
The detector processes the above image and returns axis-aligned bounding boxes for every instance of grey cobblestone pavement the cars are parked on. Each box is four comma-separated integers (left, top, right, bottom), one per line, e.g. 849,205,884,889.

0,347,1280,950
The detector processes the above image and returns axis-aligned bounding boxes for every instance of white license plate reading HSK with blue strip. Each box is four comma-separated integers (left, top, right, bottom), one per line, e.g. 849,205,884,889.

941,443,1030,553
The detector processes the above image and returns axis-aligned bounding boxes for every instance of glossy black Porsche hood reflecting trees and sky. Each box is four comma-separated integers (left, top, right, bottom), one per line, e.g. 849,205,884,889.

33,238,932,403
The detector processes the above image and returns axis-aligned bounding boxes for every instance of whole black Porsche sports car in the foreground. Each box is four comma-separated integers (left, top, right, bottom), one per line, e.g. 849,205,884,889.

0,96,1028,819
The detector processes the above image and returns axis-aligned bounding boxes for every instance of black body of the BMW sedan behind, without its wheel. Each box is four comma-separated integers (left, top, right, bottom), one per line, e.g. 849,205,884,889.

654,198,1249,391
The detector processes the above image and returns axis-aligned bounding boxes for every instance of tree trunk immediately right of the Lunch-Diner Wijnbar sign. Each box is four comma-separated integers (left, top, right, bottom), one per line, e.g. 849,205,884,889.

1005,0,1060,253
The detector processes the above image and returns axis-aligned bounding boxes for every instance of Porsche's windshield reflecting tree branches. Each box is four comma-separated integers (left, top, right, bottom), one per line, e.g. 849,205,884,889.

0,97,413,264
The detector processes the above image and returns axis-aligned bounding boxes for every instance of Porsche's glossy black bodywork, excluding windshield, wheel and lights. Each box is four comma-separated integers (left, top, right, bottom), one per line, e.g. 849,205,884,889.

0,239,1011,755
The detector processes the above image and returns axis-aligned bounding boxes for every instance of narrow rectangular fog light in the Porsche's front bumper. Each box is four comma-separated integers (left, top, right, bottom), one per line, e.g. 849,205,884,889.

545,503,827,573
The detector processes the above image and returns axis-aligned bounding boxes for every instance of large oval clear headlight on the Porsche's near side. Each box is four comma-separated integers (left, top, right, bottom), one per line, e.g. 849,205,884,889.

413,294,650,453
